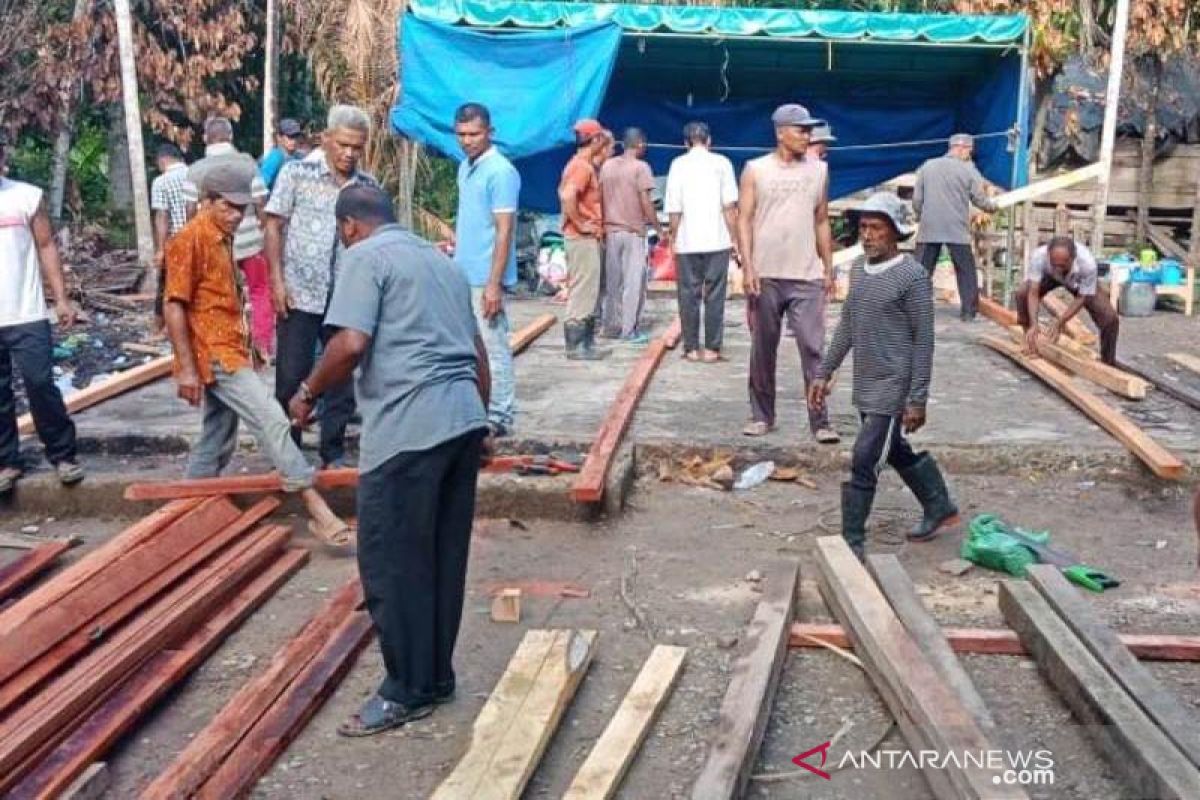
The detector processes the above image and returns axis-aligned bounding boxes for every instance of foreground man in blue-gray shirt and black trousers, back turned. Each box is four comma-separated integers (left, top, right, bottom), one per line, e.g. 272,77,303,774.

288,185,491,736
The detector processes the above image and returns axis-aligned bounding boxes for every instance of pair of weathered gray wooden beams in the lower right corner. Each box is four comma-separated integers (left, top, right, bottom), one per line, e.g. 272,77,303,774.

1000,565,1200,798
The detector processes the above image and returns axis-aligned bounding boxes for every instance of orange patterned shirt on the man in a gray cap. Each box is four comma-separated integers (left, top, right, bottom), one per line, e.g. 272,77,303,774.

166,210,251,384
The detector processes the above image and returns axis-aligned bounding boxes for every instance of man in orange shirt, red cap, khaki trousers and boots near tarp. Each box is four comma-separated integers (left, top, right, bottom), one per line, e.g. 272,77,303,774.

558,120,608,361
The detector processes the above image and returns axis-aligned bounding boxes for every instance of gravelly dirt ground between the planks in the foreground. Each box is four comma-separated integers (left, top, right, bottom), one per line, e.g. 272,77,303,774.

0,465,1200,800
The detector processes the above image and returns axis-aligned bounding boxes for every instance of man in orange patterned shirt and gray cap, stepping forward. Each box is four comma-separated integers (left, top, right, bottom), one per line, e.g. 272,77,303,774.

163,163,350,546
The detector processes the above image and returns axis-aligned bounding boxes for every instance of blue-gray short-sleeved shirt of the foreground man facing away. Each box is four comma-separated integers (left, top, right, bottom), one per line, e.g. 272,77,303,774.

325,225,487,473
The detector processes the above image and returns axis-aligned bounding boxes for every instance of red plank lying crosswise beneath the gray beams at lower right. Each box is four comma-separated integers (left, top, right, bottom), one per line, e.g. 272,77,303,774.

788,622,1200,661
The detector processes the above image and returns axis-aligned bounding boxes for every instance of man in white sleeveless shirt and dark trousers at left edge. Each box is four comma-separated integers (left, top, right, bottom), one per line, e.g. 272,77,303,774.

0,133,84,494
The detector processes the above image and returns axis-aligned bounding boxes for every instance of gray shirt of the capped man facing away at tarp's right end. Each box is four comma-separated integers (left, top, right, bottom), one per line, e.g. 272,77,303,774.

912,156,996,245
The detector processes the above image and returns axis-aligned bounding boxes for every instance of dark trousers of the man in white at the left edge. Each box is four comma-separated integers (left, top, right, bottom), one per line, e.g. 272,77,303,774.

0,320,76,469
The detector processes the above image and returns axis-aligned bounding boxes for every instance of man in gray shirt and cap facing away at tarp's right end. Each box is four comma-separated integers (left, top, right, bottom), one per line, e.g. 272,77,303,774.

912,133,996,323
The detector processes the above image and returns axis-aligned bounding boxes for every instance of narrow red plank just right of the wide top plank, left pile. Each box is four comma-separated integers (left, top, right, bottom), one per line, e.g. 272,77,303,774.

0,498,280,712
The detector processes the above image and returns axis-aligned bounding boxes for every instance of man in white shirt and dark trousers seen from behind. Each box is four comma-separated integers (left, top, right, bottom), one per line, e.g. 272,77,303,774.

664,122,738,362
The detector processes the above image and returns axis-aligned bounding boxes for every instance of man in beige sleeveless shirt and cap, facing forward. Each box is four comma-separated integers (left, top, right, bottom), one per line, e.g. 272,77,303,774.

738,103,838,444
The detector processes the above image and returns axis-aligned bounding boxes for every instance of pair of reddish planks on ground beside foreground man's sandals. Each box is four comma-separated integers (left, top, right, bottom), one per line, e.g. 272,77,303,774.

142,578,372,800
